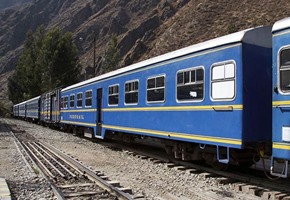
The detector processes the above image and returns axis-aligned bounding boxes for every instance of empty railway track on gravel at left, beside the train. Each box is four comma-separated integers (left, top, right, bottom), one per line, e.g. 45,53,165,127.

3,121,143,200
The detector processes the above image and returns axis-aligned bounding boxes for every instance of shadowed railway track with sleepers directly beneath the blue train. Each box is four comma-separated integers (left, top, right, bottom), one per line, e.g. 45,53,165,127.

98,141,290,200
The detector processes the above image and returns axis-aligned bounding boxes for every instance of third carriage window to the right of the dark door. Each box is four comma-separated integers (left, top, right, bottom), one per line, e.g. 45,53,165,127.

147,75,165,103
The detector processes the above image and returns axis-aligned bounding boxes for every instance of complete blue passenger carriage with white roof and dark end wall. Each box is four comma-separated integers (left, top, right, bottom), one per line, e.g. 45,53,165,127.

60,27,271,169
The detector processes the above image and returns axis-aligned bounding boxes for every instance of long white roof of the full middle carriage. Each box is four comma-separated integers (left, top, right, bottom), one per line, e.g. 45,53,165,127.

61,26,272,92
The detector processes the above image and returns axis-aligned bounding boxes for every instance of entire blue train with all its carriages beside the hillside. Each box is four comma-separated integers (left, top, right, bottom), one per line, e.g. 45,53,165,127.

13,18,290,177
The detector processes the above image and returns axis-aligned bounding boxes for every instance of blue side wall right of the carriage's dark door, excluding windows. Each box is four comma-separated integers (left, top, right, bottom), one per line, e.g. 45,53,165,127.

104,45,242,148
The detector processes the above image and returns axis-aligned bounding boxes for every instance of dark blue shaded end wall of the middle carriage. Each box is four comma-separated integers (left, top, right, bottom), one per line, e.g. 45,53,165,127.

243,44,272,144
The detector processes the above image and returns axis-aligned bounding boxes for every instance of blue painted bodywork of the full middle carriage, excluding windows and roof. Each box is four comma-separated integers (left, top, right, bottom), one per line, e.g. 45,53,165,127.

61,37,271,151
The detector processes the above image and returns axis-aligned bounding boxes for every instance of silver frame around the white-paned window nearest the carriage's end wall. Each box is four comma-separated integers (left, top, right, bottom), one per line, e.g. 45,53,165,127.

209,60,237,102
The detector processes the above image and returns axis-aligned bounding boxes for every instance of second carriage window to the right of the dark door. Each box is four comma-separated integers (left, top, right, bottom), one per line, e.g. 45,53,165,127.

125,81,139,104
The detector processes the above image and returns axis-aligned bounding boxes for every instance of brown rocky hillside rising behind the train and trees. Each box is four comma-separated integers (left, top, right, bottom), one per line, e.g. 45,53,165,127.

0,0,290,103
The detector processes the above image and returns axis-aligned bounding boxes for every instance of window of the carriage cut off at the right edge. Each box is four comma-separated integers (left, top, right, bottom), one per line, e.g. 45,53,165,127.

279,49,290,93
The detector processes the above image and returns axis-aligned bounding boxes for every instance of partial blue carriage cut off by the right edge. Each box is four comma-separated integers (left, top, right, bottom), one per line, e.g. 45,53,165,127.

271,18,290,177
